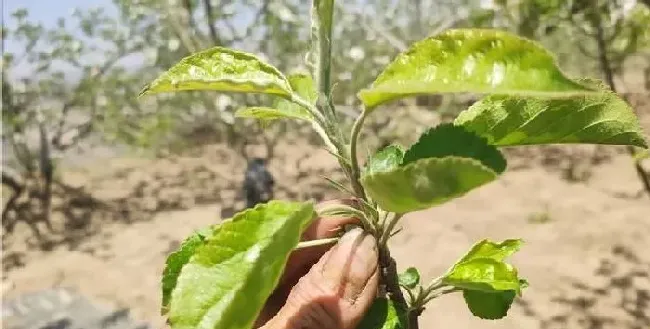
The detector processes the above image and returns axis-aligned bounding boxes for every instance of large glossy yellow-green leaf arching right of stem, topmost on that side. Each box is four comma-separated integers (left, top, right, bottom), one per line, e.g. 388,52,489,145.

359,29,593,109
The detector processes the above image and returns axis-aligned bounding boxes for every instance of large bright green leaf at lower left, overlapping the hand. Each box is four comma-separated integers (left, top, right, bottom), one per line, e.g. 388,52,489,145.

169,201,315,329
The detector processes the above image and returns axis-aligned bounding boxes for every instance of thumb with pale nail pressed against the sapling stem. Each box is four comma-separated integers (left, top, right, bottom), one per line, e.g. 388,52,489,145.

262,229,379,329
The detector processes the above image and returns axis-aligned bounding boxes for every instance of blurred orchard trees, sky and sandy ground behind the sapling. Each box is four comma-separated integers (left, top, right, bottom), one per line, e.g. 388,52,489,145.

2,0,650,329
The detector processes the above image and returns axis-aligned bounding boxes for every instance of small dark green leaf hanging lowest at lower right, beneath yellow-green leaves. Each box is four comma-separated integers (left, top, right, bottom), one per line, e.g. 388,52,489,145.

463,290,517,320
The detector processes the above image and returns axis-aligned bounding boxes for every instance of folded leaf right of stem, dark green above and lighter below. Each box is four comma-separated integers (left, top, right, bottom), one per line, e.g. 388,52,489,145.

361,124,506,213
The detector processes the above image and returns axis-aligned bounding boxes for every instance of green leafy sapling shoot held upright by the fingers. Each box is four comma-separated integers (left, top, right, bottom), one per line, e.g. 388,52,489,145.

141,0,647,329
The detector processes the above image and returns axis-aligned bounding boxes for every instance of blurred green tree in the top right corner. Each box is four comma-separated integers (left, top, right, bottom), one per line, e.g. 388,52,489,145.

491,0,650,196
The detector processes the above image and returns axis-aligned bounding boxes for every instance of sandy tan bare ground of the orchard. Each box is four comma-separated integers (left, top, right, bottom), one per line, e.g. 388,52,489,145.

3,101,650,329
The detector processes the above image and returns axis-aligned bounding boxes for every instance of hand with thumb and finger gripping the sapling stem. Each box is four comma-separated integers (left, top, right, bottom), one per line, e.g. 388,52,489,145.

254,200,379,329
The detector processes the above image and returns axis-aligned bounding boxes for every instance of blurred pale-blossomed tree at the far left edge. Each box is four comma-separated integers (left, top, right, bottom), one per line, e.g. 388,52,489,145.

2,9,143,240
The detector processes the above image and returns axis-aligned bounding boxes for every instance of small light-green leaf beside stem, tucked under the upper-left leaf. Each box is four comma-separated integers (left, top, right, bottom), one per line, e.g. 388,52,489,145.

235,73,318,121
